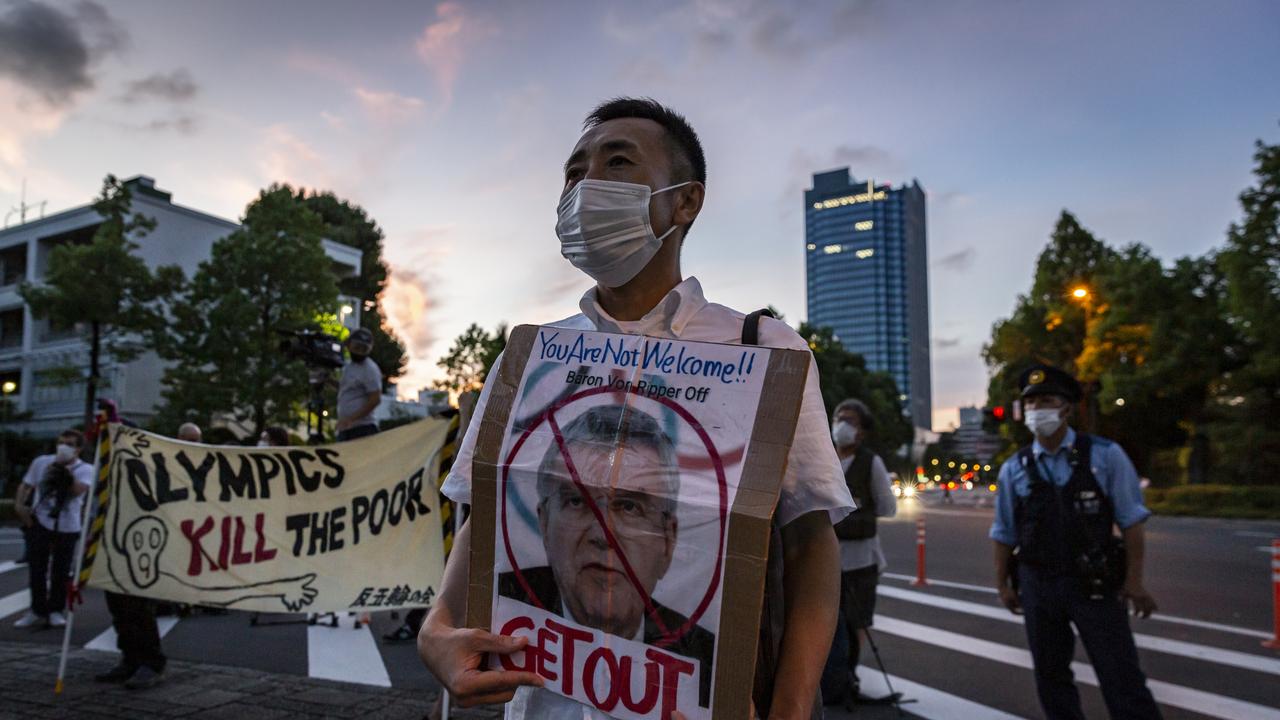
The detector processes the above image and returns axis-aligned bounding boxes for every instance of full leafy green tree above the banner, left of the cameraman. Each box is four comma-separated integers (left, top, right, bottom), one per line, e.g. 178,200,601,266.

156,184,338,436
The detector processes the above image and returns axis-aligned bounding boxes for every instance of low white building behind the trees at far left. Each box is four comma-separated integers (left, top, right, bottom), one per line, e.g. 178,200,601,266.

0,176,361,436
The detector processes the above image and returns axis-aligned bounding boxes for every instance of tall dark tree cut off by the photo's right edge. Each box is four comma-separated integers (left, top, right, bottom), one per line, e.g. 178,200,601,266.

1213,135,1280,484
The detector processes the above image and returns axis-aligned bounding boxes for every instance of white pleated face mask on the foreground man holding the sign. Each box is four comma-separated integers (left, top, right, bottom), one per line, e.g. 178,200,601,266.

556,179,692,287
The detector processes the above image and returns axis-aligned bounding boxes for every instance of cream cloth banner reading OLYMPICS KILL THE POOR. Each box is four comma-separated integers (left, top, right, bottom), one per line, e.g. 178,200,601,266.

90,418,449,612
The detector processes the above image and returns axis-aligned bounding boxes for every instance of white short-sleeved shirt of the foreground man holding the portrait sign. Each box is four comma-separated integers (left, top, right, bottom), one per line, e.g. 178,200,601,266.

440,277,854,720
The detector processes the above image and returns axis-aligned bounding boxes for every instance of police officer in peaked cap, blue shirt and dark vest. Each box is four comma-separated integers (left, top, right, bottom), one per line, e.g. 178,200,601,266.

991,365,1160,720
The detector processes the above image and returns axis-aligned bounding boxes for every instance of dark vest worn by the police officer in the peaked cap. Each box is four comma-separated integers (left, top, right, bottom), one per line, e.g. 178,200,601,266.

1014,433,1125,600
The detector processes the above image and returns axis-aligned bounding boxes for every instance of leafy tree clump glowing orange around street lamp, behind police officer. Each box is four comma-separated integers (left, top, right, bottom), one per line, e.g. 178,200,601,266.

983,213,1231,480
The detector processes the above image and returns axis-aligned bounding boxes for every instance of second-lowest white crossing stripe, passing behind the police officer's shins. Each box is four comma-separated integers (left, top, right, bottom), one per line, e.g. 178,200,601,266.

874,615,1280,720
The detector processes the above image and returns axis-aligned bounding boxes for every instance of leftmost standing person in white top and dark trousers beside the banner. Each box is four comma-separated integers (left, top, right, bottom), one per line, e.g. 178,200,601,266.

13,429,93,628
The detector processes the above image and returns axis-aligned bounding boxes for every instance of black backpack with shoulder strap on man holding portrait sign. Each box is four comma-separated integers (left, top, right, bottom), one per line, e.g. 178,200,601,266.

742,310,823,720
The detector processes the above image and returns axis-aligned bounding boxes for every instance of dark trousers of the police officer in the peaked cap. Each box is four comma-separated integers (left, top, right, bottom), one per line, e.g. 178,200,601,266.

1019,566,1160,720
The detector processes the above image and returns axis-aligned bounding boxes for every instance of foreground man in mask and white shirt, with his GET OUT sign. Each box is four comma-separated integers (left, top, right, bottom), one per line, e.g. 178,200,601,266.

419,100,852,720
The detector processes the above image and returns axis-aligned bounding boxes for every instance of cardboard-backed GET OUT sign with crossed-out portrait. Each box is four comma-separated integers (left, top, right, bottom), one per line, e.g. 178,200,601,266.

467,325,809,720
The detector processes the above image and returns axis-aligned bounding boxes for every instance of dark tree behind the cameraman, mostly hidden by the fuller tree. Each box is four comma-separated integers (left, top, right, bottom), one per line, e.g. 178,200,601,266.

296,190,408,387
